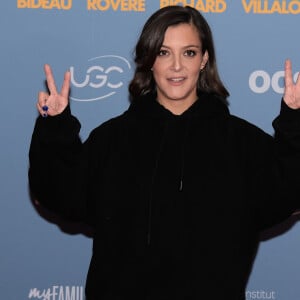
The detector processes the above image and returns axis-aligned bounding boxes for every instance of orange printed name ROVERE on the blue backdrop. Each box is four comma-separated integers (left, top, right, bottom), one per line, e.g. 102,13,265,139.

87,0,146,11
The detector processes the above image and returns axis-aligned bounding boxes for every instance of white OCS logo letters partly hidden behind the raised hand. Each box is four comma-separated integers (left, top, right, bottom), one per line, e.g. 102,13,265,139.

249,70,299,94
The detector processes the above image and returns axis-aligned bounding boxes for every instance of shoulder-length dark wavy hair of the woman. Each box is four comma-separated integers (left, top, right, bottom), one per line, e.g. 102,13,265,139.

129,6,229,100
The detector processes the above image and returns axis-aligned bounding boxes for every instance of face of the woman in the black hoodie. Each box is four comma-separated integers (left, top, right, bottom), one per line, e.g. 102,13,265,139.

152,23,208,112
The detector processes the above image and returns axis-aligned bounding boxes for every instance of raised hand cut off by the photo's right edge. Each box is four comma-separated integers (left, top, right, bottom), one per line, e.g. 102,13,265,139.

283,59,300,109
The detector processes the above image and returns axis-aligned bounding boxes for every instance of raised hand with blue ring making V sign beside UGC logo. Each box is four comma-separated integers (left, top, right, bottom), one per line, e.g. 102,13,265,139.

37,64,71,117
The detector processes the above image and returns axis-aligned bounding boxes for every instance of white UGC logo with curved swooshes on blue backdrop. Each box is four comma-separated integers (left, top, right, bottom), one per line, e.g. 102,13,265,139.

70,55,131,101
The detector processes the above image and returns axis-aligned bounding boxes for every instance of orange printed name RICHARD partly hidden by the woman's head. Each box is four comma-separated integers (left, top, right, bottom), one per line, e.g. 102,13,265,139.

160,0,227,13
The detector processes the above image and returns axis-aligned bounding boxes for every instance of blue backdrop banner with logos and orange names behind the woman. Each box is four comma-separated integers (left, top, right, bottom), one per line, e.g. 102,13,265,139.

0,0,300,300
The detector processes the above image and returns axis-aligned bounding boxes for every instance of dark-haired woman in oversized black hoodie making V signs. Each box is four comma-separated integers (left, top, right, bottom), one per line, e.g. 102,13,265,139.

29,6,300,300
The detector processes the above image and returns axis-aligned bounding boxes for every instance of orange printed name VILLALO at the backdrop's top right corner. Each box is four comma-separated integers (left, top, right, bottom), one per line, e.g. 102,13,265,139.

242,0,300,14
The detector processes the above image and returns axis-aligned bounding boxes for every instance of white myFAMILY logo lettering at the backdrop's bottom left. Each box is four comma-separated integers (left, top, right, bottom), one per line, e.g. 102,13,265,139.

28,285,84,300
